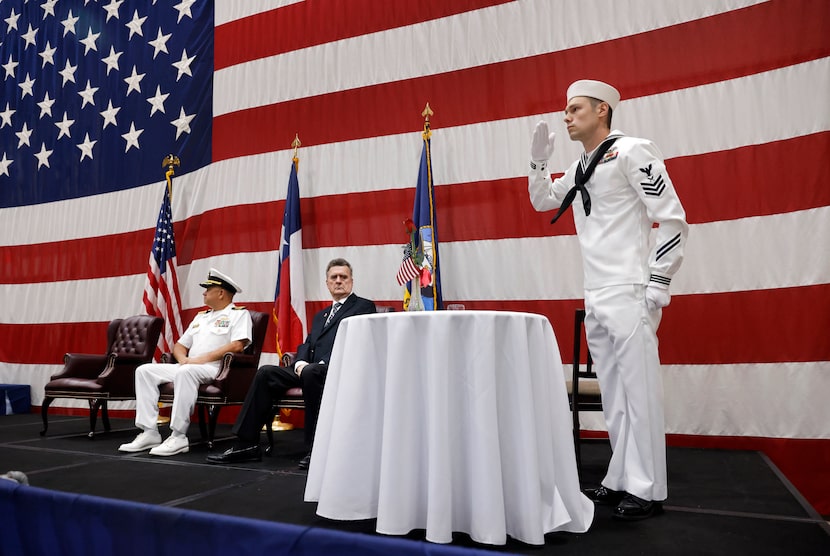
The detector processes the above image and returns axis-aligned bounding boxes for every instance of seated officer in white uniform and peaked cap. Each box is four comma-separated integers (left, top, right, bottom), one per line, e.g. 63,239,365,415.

118,268,253,456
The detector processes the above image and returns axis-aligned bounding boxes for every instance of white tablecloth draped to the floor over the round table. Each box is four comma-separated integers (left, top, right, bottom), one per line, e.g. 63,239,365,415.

305,311,594,545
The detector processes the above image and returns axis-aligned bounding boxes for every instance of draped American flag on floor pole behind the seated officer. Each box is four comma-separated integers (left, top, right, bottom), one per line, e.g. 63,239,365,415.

143,182,184,361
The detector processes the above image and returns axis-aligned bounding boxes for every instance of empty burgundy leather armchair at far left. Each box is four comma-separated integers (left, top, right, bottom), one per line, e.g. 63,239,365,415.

40,315,164,438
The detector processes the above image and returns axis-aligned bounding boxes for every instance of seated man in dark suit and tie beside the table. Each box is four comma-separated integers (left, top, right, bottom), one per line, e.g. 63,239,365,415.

207,259,376,469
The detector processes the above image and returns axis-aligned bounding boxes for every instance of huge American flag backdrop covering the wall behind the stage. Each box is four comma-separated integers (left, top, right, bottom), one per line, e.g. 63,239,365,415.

0,0,830,514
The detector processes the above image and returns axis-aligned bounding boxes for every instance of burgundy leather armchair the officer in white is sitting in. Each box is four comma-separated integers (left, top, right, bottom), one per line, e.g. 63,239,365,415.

159,311,270,448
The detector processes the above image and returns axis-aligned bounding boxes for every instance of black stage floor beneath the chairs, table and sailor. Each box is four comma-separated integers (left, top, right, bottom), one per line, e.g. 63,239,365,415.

0,415,830,556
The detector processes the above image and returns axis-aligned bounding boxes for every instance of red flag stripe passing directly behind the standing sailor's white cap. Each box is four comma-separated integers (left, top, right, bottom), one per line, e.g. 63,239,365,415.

213,0,830,161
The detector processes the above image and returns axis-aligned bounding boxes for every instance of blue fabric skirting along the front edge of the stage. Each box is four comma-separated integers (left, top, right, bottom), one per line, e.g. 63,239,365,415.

0,480,508,556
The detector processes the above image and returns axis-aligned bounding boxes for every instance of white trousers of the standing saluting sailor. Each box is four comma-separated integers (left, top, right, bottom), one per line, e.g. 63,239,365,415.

585,284,668,500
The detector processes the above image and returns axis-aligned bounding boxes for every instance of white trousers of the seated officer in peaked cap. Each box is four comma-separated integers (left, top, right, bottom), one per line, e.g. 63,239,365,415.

135,363,219,434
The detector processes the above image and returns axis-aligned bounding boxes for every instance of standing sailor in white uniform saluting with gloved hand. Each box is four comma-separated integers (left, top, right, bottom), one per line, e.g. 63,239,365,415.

528,80,688,520
